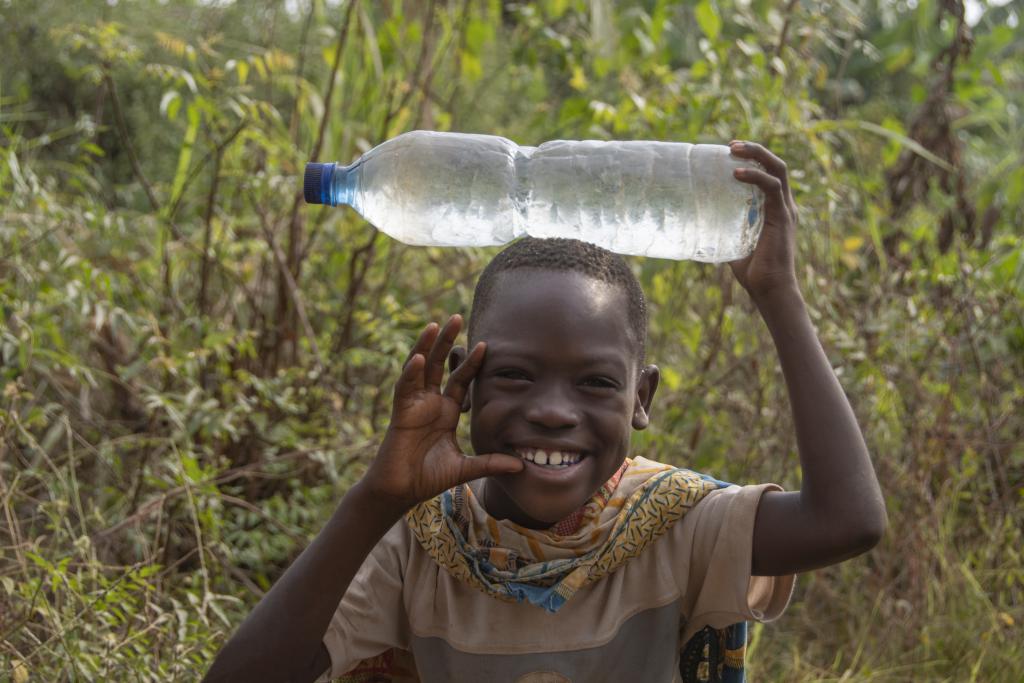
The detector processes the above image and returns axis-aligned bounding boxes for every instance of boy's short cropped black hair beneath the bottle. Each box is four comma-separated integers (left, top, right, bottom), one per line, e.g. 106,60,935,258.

469,238,647,364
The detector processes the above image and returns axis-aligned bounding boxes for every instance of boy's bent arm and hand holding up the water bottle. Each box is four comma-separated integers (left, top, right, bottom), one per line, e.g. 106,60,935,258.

730,142,886,575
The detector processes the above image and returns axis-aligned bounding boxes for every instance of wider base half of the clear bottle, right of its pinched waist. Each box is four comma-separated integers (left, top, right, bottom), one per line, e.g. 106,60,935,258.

524,140,763,262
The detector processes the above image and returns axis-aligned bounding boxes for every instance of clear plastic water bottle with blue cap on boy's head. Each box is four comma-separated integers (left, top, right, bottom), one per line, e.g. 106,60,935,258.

304,131,764,263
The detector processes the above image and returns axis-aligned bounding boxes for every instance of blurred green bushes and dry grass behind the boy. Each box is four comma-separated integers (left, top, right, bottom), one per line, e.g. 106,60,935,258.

0,0,1024,683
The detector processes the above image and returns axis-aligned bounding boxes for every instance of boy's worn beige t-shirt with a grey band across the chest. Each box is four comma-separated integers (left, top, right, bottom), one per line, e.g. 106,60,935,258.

321,484,794,683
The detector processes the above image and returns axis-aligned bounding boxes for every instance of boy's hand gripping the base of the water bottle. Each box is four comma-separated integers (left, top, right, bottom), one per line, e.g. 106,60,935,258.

729,140,797,300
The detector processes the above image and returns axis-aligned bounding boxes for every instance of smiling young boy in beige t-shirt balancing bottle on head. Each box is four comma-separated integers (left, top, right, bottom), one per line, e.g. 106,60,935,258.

208,141,886,683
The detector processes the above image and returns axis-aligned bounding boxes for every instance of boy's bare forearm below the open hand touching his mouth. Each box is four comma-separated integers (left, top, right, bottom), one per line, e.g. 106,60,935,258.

204,483,404,681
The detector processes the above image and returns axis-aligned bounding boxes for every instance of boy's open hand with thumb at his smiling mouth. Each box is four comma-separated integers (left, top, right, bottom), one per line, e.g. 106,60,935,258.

362,315,523,509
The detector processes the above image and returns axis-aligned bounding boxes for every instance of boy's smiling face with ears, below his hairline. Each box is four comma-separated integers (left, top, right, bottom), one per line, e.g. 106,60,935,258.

453,268,658,528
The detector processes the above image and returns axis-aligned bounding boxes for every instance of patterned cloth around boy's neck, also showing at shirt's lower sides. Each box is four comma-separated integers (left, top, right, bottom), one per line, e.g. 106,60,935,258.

339,458,746,683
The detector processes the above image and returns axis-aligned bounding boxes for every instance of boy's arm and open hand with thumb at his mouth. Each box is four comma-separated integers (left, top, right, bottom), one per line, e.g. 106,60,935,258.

204,315,523,681
